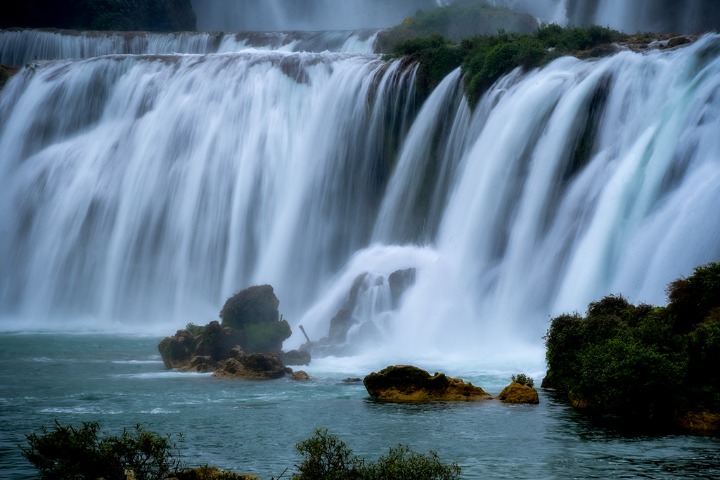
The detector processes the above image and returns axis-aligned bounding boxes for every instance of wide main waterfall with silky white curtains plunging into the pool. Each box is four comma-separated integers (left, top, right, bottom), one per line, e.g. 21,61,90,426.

0,30,720,355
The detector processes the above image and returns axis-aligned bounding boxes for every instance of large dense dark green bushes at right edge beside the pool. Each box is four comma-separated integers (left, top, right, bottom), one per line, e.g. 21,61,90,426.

545,263,720,420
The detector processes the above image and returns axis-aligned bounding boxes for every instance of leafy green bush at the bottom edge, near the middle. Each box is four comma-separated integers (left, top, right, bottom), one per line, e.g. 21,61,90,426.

292,429,460,480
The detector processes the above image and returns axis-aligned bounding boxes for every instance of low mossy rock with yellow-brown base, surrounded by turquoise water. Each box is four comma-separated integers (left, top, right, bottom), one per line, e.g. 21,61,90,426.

363,365,492,402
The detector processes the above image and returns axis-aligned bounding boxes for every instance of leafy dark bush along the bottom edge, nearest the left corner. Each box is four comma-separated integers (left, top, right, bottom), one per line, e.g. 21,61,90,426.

21,421,180,480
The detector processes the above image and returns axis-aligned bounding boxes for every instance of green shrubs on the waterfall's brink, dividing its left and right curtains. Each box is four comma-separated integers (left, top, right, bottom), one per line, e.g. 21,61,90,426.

391,25,626,106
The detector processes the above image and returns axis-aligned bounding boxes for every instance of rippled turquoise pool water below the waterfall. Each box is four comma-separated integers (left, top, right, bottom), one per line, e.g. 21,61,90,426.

0,333,720,479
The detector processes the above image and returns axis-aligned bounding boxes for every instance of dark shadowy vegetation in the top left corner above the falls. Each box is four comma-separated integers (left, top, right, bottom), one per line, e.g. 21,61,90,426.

0,0,196,32
